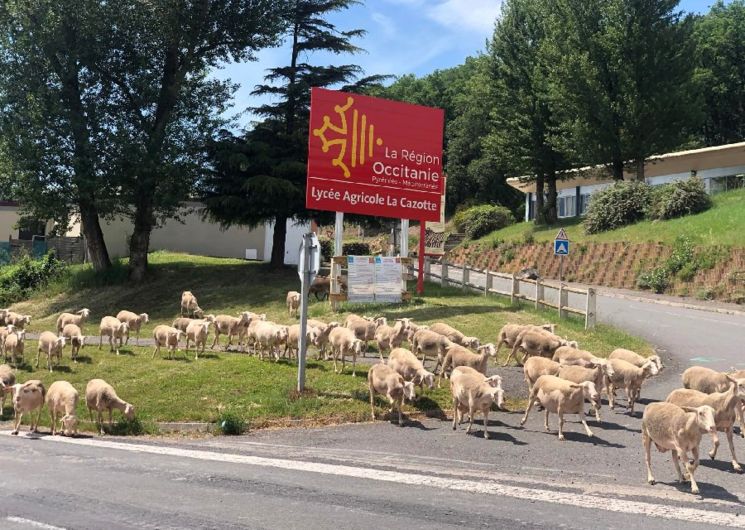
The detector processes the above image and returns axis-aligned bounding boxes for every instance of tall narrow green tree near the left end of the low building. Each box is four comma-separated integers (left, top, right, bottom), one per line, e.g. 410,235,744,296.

484,0,566,224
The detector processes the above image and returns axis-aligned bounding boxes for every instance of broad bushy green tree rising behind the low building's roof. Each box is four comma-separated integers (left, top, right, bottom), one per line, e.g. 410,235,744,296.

546,0,699,180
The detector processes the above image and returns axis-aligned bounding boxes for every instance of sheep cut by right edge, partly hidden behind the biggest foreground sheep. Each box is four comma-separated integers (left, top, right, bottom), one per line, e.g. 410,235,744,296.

666,379,745,471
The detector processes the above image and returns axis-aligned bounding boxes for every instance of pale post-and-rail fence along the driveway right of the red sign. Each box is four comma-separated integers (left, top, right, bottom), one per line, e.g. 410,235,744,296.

424,258,597,329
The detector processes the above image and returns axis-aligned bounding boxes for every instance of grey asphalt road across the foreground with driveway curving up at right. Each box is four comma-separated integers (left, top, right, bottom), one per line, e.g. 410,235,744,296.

0,280,745,529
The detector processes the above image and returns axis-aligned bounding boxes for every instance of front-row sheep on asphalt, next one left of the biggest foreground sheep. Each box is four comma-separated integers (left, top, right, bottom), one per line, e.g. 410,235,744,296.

520,375,600,441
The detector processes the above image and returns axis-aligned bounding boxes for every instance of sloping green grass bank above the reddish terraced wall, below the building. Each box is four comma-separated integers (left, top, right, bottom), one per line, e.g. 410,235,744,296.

478,190,745,247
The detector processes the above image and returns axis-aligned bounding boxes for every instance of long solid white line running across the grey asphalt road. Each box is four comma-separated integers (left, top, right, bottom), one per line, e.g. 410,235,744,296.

10,436,745,528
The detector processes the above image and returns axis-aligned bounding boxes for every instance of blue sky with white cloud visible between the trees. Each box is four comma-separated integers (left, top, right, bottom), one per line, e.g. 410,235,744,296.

215,0,728,126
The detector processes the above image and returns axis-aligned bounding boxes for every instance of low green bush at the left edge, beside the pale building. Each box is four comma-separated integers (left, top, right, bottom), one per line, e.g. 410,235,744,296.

0,253,65,307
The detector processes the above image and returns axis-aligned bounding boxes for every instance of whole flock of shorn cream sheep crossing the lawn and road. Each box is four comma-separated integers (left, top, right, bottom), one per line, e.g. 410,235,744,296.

0,284,745,493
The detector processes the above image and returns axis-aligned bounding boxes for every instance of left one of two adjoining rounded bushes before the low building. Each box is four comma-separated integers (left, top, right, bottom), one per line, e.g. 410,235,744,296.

584,182,651,234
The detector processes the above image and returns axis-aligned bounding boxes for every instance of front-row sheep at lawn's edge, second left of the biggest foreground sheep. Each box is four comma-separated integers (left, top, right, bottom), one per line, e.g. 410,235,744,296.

450,366,504,438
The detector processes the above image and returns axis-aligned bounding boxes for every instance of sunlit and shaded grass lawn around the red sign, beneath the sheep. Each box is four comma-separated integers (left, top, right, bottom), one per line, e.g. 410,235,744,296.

3,253,652,430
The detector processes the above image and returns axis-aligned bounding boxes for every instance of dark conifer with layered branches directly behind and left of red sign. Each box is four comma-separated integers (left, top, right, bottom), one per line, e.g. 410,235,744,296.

202,0,385,267
